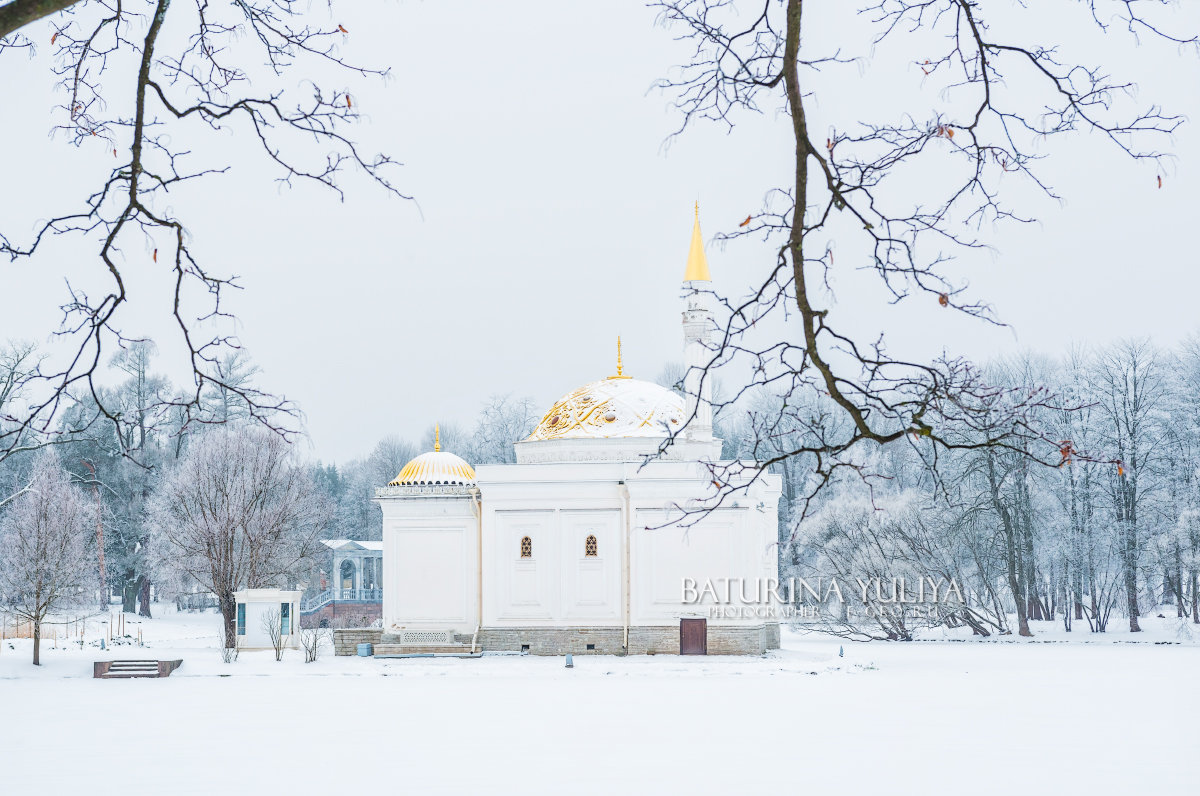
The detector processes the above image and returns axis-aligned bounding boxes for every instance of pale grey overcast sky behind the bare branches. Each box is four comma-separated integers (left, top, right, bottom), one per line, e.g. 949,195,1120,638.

0,1,1200,462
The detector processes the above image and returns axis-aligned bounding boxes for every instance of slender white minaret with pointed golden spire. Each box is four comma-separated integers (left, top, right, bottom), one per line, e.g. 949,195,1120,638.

683,202,713,442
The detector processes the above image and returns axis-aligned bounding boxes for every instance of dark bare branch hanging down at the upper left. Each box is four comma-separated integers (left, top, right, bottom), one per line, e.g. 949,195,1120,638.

0,0,408,460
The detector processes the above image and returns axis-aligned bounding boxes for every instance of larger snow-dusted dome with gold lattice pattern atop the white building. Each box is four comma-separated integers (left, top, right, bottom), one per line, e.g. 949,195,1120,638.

527,376,685,441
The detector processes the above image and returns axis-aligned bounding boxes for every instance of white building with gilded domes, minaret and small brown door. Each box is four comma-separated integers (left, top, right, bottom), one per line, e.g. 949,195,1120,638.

376,210,781,654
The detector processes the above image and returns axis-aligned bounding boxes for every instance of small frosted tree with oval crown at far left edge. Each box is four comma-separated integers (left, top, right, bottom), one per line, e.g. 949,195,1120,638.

0,449,95,665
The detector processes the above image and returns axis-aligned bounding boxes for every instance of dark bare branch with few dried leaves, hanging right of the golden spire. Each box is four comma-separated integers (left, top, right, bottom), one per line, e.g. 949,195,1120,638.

655,0,1196,520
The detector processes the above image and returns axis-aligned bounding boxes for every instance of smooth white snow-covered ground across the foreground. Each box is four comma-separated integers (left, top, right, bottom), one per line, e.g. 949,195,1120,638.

0,606,1200,796
